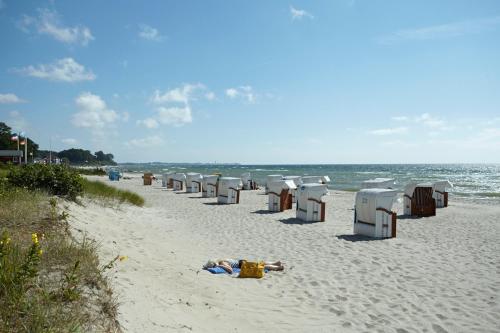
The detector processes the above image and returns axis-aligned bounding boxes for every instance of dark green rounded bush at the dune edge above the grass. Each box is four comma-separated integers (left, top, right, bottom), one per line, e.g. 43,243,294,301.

7,164,83,200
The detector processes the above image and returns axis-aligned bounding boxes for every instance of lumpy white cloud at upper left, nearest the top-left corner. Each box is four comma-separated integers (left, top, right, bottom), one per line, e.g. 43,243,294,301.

18,8,94,46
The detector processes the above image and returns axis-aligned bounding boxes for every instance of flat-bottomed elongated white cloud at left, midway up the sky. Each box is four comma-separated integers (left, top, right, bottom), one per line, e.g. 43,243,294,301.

13,58,96,82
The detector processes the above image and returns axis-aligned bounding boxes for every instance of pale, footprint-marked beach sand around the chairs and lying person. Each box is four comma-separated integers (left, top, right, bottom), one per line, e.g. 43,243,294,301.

67,175,500,333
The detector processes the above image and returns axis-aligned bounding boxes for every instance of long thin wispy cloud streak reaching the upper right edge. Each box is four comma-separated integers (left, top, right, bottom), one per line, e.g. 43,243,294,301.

375,16,500,44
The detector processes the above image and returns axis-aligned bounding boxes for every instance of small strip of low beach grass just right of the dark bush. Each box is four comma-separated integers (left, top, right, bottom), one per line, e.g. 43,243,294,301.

83,179,144,207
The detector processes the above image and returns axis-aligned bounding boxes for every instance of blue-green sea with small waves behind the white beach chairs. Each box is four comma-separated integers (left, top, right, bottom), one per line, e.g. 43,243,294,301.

119,162,500,204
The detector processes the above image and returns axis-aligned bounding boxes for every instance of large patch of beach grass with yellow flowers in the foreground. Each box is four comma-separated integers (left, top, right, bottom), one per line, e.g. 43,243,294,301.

0,185,120,332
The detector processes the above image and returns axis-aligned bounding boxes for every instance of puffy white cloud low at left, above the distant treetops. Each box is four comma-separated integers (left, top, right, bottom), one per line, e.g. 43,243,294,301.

72,92,119,131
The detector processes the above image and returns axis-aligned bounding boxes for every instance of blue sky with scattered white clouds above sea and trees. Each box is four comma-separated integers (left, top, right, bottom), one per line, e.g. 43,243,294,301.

0,0,500,164
